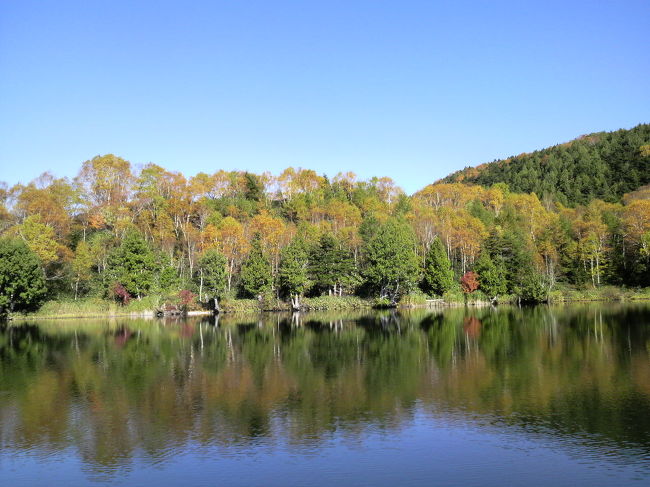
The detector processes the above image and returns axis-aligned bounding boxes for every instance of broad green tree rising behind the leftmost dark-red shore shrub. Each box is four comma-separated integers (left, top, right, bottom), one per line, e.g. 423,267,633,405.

108,230,157,299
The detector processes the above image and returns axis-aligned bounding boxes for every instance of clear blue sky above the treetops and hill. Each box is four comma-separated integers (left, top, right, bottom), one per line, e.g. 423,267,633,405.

0,0,650,192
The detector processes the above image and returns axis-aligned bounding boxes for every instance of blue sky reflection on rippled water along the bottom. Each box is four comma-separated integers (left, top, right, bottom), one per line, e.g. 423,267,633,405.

5,411,650,487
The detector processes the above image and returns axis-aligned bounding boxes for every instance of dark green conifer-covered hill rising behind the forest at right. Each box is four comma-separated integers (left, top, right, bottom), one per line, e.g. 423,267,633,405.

441,124,650,205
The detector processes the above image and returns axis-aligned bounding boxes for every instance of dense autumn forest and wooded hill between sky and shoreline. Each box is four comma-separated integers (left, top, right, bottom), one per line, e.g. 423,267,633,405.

0,125,650,311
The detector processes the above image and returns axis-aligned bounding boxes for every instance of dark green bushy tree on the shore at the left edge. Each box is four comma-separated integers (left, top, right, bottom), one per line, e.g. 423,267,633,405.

0,239,47,315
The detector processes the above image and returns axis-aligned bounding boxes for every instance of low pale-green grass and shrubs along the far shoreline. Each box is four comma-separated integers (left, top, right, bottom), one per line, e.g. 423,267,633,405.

12,286,650,319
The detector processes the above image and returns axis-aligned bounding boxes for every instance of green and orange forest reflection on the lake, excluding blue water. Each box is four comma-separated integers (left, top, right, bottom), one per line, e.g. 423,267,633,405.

0,305,650,482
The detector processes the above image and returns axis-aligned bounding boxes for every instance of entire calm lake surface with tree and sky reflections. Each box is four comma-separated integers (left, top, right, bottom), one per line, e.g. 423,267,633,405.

0,304,650,487
